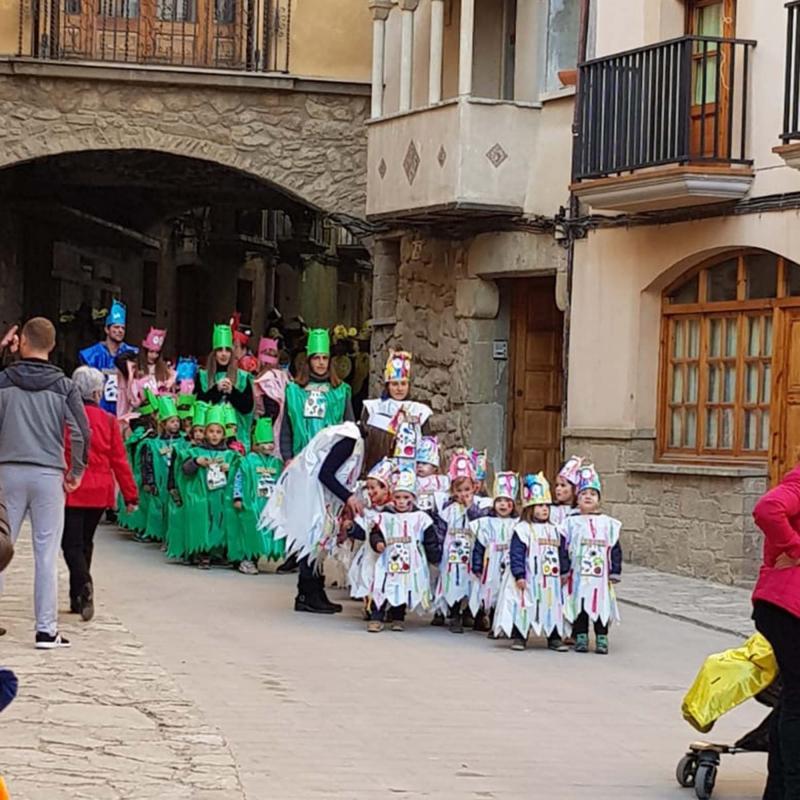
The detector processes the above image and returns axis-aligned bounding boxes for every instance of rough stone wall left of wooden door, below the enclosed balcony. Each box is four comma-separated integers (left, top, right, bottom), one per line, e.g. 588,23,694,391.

371,235,508,469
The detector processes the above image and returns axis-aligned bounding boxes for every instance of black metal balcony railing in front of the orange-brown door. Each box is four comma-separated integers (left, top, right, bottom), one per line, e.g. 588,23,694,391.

573,36,755,180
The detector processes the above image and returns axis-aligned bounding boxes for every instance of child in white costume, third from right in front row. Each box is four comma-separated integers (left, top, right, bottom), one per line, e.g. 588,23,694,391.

469,472,519,633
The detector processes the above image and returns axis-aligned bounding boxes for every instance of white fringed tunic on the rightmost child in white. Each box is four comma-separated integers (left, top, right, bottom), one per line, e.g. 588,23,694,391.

563,514,622,625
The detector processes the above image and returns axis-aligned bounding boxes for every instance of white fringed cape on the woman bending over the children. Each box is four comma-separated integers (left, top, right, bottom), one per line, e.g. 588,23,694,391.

259,422,364,563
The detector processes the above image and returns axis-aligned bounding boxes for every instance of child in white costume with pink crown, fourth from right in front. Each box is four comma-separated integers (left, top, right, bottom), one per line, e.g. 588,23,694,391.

436,451,486,633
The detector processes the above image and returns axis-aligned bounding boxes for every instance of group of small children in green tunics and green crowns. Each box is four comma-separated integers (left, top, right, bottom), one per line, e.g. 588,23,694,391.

118,325,284,574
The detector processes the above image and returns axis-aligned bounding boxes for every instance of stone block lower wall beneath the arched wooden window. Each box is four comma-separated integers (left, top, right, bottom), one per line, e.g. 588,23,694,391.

565,432,767,585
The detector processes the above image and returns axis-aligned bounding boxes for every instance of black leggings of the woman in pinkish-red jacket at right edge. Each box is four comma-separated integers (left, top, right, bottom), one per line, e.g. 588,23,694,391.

753,600,800,800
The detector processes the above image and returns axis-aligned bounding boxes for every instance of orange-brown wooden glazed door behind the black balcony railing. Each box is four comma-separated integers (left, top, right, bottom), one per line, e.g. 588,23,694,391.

686,0,736,160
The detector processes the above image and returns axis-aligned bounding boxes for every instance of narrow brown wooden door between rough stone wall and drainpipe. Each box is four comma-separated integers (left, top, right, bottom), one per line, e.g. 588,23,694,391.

508,278,563,479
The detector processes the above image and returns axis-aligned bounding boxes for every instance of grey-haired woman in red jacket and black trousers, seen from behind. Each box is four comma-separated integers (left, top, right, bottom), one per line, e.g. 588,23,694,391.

61,367,139,622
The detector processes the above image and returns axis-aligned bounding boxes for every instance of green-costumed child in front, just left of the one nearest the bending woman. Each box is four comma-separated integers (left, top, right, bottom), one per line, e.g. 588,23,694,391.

178,406,241,569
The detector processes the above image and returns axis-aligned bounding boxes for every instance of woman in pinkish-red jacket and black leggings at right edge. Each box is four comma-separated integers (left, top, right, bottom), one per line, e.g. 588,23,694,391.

753,467,800,800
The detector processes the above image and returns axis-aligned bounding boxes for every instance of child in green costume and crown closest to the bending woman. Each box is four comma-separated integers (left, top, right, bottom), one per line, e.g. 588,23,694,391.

231,417,286,575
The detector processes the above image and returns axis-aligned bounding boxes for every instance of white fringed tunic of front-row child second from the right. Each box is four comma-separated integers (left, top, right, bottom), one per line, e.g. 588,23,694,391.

494,522,564,637
